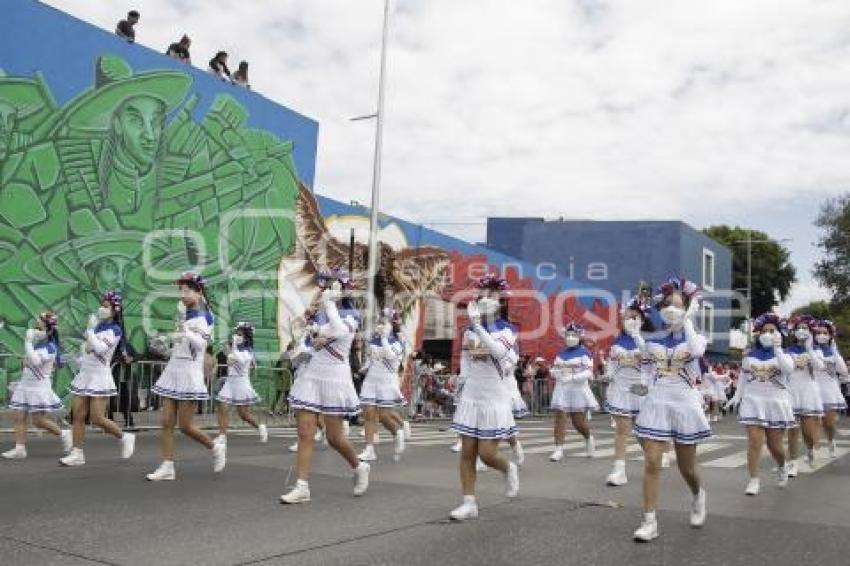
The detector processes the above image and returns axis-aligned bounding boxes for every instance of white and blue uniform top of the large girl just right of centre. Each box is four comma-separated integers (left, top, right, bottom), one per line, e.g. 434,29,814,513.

460,320,518,380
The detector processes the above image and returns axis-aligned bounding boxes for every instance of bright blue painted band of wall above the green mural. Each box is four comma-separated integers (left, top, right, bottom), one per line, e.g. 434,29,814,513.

0,0,319,187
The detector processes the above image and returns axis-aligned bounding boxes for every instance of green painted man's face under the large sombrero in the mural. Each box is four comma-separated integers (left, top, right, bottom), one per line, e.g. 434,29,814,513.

114,96,165,173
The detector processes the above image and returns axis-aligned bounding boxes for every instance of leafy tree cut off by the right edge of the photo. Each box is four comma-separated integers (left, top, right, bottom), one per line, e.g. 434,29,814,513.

814,193,850,304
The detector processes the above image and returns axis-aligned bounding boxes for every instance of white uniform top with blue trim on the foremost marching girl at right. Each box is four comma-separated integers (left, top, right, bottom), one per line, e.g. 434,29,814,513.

643,330,706,387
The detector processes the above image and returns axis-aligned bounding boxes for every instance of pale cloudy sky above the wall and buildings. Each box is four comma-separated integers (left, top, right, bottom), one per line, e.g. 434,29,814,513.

41,0,850,312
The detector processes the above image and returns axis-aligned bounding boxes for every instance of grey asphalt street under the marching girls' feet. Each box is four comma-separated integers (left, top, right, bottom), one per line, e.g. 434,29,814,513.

0,415,850,566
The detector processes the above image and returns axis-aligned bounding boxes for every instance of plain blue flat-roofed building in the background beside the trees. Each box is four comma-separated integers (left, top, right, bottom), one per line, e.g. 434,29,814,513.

486,218,732,358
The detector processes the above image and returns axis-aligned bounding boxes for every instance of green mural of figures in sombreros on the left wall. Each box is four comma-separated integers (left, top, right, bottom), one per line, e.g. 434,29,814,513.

0,55,299,351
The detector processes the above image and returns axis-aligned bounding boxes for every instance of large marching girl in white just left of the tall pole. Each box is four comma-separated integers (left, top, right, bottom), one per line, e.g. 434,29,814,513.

280,268,369,503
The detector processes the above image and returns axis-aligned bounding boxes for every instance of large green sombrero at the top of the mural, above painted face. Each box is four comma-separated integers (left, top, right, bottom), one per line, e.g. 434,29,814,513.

62,55,192,130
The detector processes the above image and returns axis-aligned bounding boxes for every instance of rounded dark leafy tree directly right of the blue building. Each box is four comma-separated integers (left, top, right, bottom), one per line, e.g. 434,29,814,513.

703,225,797,325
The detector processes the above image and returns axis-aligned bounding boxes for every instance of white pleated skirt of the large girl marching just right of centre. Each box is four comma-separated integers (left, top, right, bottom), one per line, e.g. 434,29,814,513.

451,376,517,440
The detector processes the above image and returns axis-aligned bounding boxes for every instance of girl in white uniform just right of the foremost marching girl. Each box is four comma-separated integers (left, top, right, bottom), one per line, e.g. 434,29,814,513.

726,313,797,495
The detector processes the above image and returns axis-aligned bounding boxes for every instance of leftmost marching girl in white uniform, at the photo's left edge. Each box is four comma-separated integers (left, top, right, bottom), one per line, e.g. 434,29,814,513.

3,311,71,460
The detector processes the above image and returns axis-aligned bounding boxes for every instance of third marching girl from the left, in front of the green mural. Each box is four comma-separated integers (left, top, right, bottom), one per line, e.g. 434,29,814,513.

147,271,227,481
